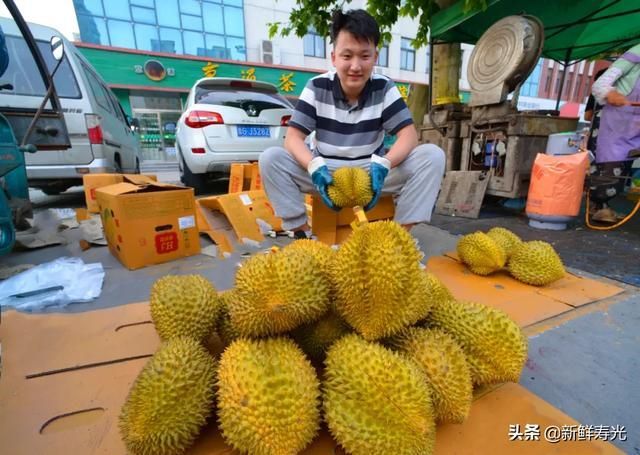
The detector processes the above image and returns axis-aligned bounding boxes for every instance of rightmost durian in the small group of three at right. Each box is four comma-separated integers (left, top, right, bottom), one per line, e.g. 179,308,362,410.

508,240,565,286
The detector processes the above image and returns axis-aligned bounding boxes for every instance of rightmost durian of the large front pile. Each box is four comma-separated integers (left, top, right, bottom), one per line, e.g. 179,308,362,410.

427,300,527,385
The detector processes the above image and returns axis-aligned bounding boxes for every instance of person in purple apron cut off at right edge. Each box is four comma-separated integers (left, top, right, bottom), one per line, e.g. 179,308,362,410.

590,44,640,223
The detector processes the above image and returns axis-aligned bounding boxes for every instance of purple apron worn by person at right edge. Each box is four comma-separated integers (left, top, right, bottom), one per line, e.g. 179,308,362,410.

596,52,640,163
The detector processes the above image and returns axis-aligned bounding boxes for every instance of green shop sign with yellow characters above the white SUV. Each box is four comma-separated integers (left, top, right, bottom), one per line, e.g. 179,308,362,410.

77,44,409,98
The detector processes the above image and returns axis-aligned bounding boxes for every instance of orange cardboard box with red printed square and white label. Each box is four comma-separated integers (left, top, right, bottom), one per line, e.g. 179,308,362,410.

96,182,200,270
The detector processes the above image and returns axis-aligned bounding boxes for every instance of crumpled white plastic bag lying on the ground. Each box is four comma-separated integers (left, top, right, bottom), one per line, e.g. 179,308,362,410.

0,257,104,311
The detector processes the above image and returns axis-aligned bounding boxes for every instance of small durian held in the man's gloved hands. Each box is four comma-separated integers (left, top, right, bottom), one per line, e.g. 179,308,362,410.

328,167,373,207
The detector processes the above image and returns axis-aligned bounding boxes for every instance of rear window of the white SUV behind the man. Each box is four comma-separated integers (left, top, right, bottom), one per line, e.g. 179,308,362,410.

195,86,293,111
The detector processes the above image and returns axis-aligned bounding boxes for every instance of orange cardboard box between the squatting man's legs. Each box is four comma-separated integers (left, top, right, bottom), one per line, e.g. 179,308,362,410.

306,195,395,245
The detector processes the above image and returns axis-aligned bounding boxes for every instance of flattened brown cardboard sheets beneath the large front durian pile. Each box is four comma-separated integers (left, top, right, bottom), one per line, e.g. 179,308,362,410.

0,296,621,455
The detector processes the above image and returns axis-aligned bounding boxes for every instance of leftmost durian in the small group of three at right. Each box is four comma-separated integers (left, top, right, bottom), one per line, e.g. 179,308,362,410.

457,231,507,275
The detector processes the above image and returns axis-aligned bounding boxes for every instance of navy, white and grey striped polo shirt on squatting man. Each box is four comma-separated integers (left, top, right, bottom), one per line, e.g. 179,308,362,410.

289,71,413,164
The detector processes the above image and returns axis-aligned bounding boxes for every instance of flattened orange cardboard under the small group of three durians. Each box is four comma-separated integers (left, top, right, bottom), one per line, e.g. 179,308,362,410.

427,253,624,327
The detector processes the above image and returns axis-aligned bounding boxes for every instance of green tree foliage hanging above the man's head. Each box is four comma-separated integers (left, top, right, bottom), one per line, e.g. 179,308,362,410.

269,0,487,48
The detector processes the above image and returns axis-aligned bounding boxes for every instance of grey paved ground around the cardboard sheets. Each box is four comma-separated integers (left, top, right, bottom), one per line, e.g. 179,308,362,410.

3,173,640,455
